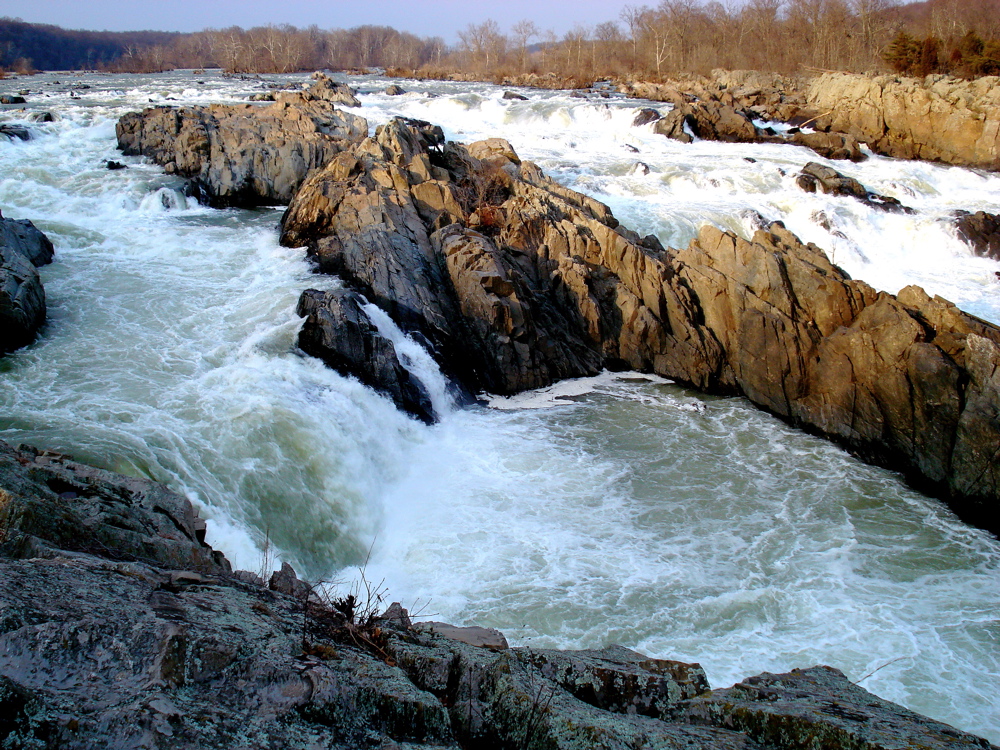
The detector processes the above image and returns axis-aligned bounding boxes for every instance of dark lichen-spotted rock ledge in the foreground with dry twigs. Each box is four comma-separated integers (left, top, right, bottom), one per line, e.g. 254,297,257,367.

0,442,993,750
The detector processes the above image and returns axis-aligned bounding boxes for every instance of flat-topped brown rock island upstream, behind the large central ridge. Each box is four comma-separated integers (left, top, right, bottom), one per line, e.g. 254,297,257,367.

116,75,368,208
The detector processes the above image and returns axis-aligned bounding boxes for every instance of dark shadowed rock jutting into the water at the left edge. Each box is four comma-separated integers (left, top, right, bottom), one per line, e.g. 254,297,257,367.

0,214,53,354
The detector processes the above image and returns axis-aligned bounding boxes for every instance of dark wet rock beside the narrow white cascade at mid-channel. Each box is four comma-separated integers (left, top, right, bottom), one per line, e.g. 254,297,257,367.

298,289,436,424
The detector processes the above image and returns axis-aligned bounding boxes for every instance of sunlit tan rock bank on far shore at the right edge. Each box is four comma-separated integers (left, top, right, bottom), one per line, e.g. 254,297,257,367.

806,73,1000,170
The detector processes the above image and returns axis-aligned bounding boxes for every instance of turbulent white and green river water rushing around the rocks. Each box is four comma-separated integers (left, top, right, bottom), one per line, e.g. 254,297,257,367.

0,72,1000,742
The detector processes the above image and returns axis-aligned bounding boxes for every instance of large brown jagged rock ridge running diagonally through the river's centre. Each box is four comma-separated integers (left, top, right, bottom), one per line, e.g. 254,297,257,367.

281,119,1000,528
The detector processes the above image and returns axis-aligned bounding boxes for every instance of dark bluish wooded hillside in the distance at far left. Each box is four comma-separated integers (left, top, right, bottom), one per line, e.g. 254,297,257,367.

0,18,182,70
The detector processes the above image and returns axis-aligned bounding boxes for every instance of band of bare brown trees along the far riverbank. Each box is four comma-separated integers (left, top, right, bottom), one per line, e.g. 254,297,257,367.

0,0,1000,79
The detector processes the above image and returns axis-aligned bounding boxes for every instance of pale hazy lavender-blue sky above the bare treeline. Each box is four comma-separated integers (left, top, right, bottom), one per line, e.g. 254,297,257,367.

0,0,640,43
